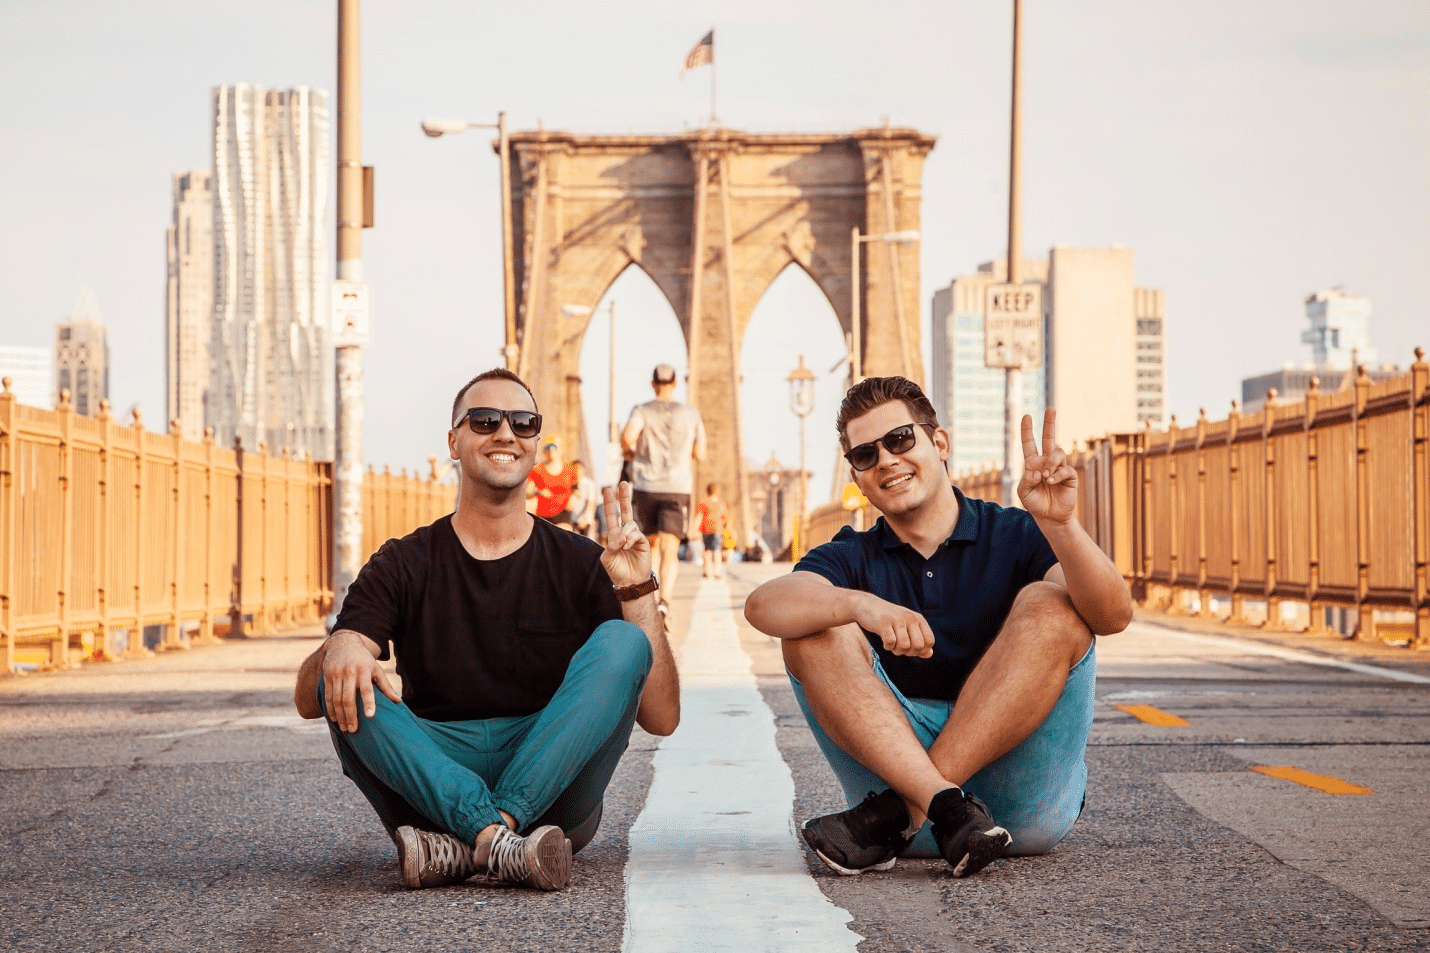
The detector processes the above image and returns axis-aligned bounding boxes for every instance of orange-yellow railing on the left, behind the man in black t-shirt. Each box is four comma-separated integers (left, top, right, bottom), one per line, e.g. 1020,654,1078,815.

0,381,453,671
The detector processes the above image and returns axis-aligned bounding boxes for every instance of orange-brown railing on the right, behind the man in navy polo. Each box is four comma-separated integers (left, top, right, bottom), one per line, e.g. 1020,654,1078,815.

807,348,1430,645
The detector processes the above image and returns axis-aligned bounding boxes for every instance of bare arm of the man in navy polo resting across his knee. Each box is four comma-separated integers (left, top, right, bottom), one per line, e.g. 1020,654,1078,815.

745,572,934,658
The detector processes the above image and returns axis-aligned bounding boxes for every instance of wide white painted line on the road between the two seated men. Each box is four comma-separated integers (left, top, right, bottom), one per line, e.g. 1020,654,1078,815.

623,580,864,953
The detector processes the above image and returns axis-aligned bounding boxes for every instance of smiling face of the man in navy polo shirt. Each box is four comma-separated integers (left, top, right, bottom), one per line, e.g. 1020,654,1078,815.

844,401,952,517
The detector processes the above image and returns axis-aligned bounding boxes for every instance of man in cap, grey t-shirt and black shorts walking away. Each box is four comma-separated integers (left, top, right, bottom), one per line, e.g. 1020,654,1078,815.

621,363,705,612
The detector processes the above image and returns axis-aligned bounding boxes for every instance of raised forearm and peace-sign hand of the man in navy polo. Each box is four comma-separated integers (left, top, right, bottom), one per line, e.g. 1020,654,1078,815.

1018,408,1133,635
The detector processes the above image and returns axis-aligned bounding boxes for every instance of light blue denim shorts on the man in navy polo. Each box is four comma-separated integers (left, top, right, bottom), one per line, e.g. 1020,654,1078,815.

789,645,1097,859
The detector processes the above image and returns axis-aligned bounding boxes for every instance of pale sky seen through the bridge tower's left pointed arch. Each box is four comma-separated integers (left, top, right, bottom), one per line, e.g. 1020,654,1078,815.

578,263,689,487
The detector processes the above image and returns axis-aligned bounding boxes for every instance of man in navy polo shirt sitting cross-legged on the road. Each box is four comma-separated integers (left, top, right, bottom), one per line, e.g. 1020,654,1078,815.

745,378,1133,876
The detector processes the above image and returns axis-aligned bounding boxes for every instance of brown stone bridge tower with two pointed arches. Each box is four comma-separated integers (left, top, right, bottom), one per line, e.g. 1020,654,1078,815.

511,127,935,544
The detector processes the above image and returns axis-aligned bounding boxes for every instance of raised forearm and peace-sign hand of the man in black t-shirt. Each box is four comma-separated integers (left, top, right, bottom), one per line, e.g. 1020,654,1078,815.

601,482,681,734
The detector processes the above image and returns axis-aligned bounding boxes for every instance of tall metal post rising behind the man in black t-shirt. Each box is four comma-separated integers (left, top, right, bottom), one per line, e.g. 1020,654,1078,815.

333,0,363,615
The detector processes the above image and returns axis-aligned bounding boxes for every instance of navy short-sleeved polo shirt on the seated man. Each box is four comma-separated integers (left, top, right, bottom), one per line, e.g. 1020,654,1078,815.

795,487,1058,701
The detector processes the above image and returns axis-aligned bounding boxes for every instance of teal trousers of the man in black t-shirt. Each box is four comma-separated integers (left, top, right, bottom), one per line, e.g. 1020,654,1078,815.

319,621,652,850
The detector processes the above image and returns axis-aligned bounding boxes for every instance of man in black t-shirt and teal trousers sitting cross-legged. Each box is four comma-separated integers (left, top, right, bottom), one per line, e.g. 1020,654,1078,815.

293,369,681,890
